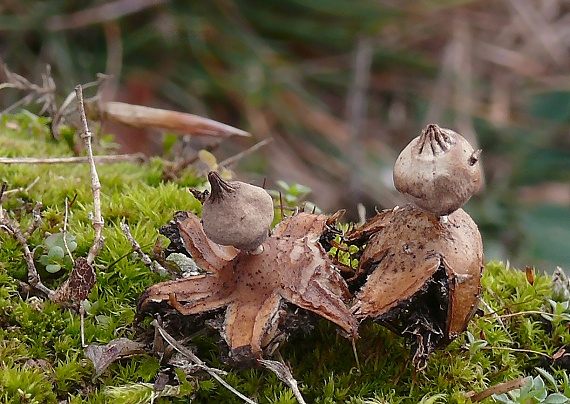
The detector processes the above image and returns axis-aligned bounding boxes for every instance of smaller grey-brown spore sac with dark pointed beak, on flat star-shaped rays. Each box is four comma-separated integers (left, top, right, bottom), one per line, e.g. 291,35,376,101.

202,171,274,254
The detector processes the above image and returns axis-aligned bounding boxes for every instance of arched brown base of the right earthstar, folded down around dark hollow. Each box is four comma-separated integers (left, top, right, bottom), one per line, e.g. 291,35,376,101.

347,205,483,363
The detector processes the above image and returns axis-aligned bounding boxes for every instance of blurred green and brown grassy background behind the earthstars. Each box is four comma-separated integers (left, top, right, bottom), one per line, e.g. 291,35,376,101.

0,0,570,272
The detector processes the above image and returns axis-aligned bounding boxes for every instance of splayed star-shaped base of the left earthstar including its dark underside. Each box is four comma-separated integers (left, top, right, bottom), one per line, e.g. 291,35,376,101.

138,208,358,367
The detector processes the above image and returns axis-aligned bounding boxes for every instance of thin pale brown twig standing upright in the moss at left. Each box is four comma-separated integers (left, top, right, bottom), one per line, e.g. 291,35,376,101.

75,85,104,264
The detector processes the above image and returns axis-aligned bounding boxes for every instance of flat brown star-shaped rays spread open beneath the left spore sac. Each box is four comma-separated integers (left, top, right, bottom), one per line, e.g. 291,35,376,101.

139,213,358,365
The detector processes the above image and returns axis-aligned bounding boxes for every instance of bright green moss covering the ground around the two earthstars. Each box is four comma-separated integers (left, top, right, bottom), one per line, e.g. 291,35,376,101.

0,114,570,403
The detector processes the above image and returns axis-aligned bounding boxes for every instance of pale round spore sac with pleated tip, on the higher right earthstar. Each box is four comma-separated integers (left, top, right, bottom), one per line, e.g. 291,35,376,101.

394,124,482,217
